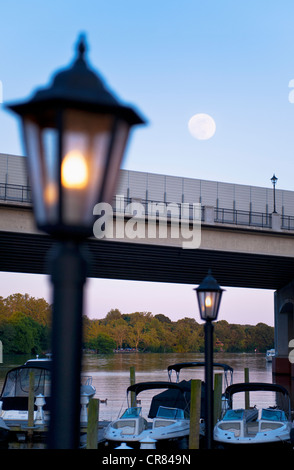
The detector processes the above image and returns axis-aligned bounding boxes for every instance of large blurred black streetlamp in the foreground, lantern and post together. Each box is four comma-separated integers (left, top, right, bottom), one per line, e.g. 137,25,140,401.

7,36,144,449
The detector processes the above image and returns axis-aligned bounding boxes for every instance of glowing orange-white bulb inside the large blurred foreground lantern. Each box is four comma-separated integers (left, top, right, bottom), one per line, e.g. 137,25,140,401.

61,150,88,189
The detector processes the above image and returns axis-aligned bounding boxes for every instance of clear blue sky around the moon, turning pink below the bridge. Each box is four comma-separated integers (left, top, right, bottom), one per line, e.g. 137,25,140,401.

0,0,294,324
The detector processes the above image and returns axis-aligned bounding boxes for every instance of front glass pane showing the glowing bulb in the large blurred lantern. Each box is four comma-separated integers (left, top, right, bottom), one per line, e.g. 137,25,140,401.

61,110,113,226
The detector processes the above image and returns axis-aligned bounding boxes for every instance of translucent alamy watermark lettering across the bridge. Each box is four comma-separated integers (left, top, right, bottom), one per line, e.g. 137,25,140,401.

93,195,201,249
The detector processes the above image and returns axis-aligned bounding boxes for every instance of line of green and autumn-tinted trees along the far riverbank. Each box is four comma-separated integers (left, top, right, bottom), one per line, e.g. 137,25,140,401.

0,294,274,354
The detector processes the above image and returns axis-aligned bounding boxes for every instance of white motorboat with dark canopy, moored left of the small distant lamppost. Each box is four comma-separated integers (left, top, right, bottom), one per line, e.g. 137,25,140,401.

104,381,191,448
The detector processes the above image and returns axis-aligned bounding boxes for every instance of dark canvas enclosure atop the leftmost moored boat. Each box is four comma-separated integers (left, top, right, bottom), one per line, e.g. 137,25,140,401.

2,367,50,397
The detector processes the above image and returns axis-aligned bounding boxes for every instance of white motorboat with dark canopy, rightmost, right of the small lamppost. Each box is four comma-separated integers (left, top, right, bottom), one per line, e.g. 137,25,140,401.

214,382,292,447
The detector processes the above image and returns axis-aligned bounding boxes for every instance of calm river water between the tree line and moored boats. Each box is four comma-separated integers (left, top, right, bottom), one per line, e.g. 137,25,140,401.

0,353,273,420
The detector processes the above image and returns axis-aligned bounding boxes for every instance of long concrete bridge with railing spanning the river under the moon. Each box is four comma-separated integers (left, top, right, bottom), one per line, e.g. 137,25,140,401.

0,154,294,396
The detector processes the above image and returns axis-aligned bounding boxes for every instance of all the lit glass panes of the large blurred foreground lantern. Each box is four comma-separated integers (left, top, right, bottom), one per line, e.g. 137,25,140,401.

24,109,129,233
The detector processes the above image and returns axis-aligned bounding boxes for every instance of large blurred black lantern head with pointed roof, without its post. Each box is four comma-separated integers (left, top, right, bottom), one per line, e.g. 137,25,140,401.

7,36,145,238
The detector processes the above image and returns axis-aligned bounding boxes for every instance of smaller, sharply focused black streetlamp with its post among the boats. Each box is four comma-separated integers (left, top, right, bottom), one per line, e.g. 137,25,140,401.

194,270,223,449
